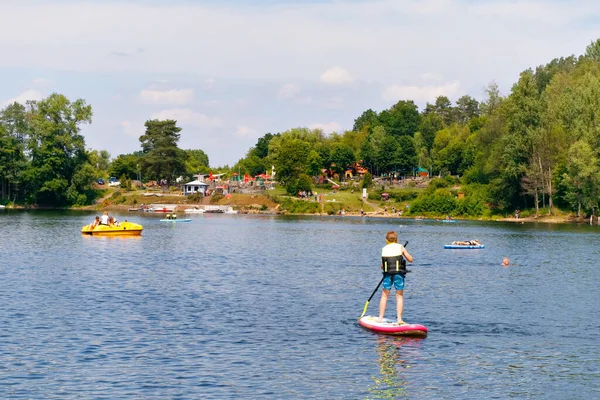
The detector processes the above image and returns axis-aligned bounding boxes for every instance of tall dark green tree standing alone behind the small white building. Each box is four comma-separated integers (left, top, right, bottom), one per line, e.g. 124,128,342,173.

140,119,186,183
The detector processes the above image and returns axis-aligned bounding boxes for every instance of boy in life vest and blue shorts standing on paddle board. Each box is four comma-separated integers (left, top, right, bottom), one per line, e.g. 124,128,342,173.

378,231,413,324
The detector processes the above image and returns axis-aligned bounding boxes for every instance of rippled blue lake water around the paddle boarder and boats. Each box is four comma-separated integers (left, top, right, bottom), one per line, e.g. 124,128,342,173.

0,210,600,399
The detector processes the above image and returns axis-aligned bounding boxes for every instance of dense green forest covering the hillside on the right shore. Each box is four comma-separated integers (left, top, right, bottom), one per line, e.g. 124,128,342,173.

233,39,600,216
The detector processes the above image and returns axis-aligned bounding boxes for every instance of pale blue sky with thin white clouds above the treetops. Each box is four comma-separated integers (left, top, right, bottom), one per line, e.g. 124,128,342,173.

0,0,600,166
